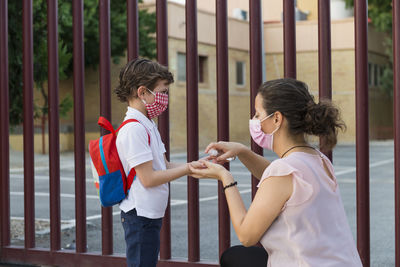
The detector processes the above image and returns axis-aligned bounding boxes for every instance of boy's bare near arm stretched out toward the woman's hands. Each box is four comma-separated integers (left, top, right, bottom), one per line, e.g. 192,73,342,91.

135,160,190,187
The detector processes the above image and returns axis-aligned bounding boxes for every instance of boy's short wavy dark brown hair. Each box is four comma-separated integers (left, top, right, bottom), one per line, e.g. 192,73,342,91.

114,58,174,102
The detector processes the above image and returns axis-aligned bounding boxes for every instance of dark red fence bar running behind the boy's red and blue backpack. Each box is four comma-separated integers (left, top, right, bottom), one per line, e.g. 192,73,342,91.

99,0,113,255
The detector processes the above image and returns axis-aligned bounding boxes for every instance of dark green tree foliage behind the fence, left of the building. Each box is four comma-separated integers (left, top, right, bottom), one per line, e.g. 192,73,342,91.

8,0,156,125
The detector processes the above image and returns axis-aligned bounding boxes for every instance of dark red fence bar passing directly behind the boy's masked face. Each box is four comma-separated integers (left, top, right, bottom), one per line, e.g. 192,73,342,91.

156,0,171,260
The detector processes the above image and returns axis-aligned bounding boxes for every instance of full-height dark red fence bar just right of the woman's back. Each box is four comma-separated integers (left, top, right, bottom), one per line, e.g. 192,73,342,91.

354,0,370,267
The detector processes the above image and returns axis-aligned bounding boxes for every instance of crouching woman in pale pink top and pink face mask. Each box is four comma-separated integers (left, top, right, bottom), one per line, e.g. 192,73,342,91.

191,78,362,267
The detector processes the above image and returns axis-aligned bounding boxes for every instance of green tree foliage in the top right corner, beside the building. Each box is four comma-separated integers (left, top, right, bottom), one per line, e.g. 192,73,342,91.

346,0,393,95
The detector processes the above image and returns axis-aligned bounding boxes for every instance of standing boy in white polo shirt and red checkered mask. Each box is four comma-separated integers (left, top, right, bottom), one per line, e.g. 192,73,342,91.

115,58,190,267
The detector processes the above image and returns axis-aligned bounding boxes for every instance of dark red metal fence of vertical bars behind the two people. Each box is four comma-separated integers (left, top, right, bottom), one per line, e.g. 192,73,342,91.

0,0,400,267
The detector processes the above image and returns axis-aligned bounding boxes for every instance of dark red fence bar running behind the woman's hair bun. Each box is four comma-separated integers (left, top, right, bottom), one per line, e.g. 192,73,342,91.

318,0,332,161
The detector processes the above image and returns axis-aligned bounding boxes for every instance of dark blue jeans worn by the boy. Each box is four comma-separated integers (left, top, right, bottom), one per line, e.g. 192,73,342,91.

121,209,162,267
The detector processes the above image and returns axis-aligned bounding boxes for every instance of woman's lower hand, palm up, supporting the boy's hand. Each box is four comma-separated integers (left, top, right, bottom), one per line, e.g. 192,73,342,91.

189,160,231,181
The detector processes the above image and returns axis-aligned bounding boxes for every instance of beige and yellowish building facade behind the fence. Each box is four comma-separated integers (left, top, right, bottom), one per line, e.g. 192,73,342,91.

10,0,393,152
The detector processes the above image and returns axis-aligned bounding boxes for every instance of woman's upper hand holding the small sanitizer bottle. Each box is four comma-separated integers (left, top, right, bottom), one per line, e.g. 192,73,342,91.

205,141,245,164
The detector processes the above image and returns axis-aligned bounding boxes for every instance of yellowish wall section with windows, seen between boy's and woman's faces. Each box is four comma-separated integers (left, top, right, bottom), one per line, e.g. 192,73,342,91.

169,38,250,151
